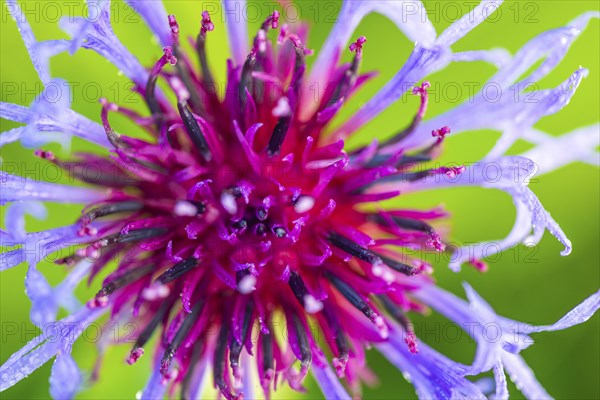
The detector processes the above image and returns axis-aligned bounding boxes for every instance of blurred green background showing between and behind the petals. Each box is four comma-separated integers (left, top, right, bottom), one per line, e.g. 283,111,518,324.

0,0,600,399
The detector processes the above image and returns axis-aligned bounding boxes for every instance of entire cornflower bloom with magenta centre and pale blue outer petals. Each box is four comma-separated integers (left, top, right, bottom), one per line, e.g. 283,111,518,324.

0,0,600,399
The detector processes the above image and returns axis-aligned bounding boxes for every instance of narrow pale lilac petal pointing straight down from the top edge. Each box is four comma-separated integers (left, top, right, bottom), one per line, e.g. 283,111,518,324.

223,0,248,66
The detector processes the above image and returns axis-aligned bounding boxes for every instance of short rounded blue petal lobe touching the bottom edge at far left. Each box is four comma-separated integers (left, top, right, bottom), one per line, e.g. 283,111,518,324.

50,352,83,400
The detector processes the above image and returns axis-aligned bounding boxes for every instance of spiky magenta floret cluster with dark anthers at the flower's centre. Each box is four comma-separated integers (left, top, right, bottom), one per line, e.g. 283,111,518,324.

36,12,463,399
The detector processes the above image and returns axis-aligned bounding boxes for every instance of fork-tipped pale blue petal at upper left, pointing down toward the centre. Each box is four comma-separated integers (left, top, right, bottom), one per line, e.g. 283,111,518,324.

60,1,148,87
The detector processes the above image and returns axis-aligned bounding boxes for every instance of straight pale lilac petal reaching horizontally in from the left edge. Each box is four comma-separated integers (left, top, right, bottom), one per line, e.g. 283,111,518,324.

0,171,105,205
